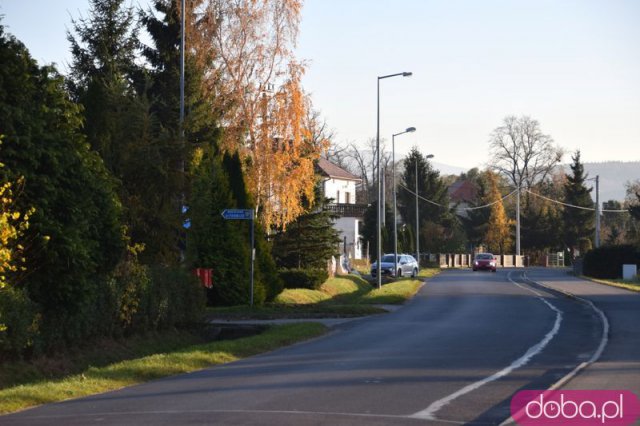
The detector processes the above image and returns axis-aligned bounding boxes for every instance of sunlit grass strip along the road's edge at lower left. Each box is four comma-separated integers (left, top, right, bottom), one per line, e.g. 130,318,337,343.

0,323,327,414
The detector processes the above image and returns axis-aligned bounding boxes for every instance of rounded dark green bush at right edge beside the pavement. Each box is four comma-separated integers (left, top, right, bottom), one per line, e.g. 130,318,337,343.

583,245,640,278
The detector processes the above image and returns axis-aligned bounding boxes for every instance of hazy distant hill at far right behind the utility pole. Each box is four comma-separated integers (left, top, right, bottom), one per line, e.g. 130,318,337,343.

562,161,640,202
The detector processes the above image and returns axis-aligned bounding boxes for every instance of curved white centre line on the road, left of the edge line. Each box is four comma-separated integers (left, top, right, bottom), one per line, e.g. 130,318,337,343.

409,272,562,420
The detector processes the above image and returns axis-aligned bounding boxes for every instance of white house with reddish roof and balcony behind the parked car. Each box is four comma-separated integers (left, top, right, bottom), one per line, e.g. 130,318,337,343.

318,158,367,259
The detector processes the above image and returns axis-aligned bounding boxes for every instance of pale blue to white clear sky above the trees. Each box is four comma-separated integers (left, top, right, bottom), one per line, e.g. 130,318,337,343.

0,0,640,170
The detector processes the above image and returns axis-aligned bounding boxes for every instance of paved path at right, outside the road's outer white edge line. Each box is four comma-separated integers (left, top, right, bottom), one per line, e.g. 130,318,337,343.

527,268,640,396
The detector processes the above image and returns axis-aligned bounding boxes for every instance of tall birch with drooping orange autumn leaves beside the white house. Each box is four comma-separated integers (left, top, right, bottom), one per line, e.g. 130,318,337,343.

206,0,326,229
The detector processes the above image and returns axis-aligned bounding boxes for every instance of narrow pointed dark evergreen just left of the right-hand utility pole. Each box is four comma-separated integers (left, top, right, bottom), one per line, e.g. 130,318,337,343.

562,151,594,255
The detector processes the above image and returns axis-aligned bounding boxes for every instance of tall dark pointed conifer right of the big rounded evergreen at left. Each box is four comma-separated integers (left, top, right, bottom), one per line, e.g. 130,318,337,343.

67,0,182,264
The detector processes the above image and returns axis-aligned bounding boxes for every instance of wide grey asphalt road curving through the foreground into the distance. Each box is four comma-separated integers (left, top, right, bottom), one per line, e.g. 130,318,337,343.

0,270,640,425
